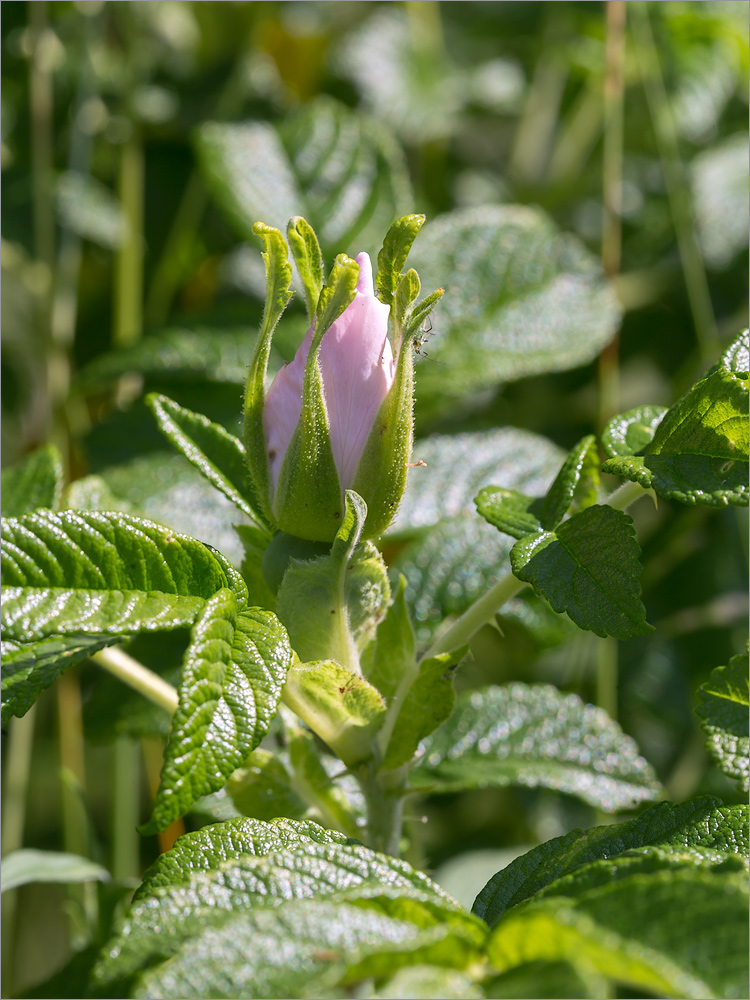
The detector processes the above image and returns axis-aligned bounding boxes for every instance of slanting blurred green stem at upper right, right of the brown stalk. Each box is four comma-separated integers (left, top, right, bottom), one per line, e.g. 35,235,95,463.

631,3,718,364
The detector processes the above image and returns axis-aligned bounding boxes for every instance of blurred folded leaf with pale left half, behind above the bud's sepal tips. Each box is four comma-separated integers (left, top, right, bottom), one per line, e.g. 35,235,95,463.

197,97,412,259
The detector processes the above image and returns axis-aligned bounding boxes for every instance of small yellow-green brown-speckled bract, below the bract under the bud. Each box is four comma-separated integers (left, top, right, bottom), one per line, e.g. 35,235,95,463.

282,660,385,767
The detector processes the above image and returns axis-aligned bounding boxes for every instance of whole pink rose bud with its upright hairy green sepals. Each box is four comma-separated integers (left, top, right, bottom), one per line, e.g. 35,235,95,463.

245,215,442,543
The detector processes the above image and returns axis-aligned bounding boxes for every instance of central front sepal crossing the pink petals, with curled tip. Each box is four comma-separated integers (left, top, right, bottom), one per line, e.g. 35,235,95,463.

273,254,359,542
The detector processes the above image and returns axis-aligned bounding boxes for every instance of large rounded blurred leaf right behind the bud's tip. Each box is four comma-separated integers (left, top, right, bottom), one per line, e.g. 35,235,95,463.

412,205,620,406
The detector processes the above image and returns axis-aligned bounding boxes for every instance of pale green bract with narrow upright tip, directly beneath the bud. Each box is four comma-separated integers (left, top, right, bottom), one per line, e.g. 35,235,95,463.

276,490,390,674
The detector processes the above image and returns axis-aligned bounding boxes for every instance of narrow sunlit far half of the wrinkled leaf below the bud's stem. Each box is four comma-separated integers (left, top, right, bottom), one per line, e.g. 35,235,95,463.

133,818,349,903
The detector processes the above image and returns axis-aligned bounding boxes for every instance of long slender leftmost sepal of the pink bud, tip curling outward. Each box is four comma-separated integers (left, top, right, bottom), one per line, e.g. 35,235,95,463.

244,222,294,522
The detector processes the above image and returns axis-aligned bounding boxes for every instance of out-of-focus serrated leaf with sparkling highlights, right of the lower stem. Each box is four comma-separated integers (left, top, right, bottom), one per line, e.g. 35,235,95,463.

411,684,659,812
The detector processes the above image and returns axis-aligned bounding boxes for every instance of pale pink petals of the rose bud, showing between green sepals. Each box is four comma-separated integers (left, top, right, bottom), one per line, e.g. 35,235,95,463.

263,253,396,496
